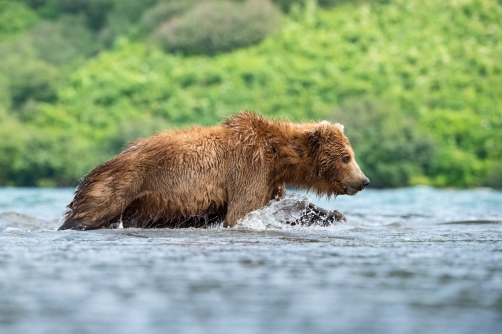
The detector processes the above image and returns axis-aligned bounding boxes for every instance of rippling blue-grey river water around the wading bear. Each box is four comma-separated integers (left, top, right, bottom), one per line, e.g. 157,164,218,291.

0,187,502,334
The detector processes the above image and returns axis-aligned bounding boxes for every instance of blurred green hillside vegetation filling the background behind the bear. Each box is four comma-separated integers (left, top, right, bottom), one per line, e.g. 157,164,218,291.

0,0,502,188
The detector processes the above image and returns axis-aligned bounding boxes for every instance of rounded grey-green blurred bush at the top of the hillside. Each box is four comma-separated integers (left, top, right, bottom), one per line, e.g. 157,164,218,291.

153,0,280,54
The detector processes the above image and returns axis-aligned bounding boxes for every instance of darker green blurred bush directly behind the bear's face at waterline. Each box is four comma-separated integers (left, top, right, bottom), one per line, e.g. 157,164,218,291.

332,97,438,188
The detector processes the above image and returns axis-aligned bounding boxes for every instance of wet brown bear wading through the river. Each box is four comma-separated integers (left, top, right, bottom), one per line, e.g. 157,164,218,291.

59,111,370,230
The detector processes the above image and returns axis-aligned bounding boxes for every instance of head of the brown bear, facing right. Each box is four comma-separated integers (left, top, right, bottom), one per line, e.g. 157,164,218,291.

308,121,370,195
